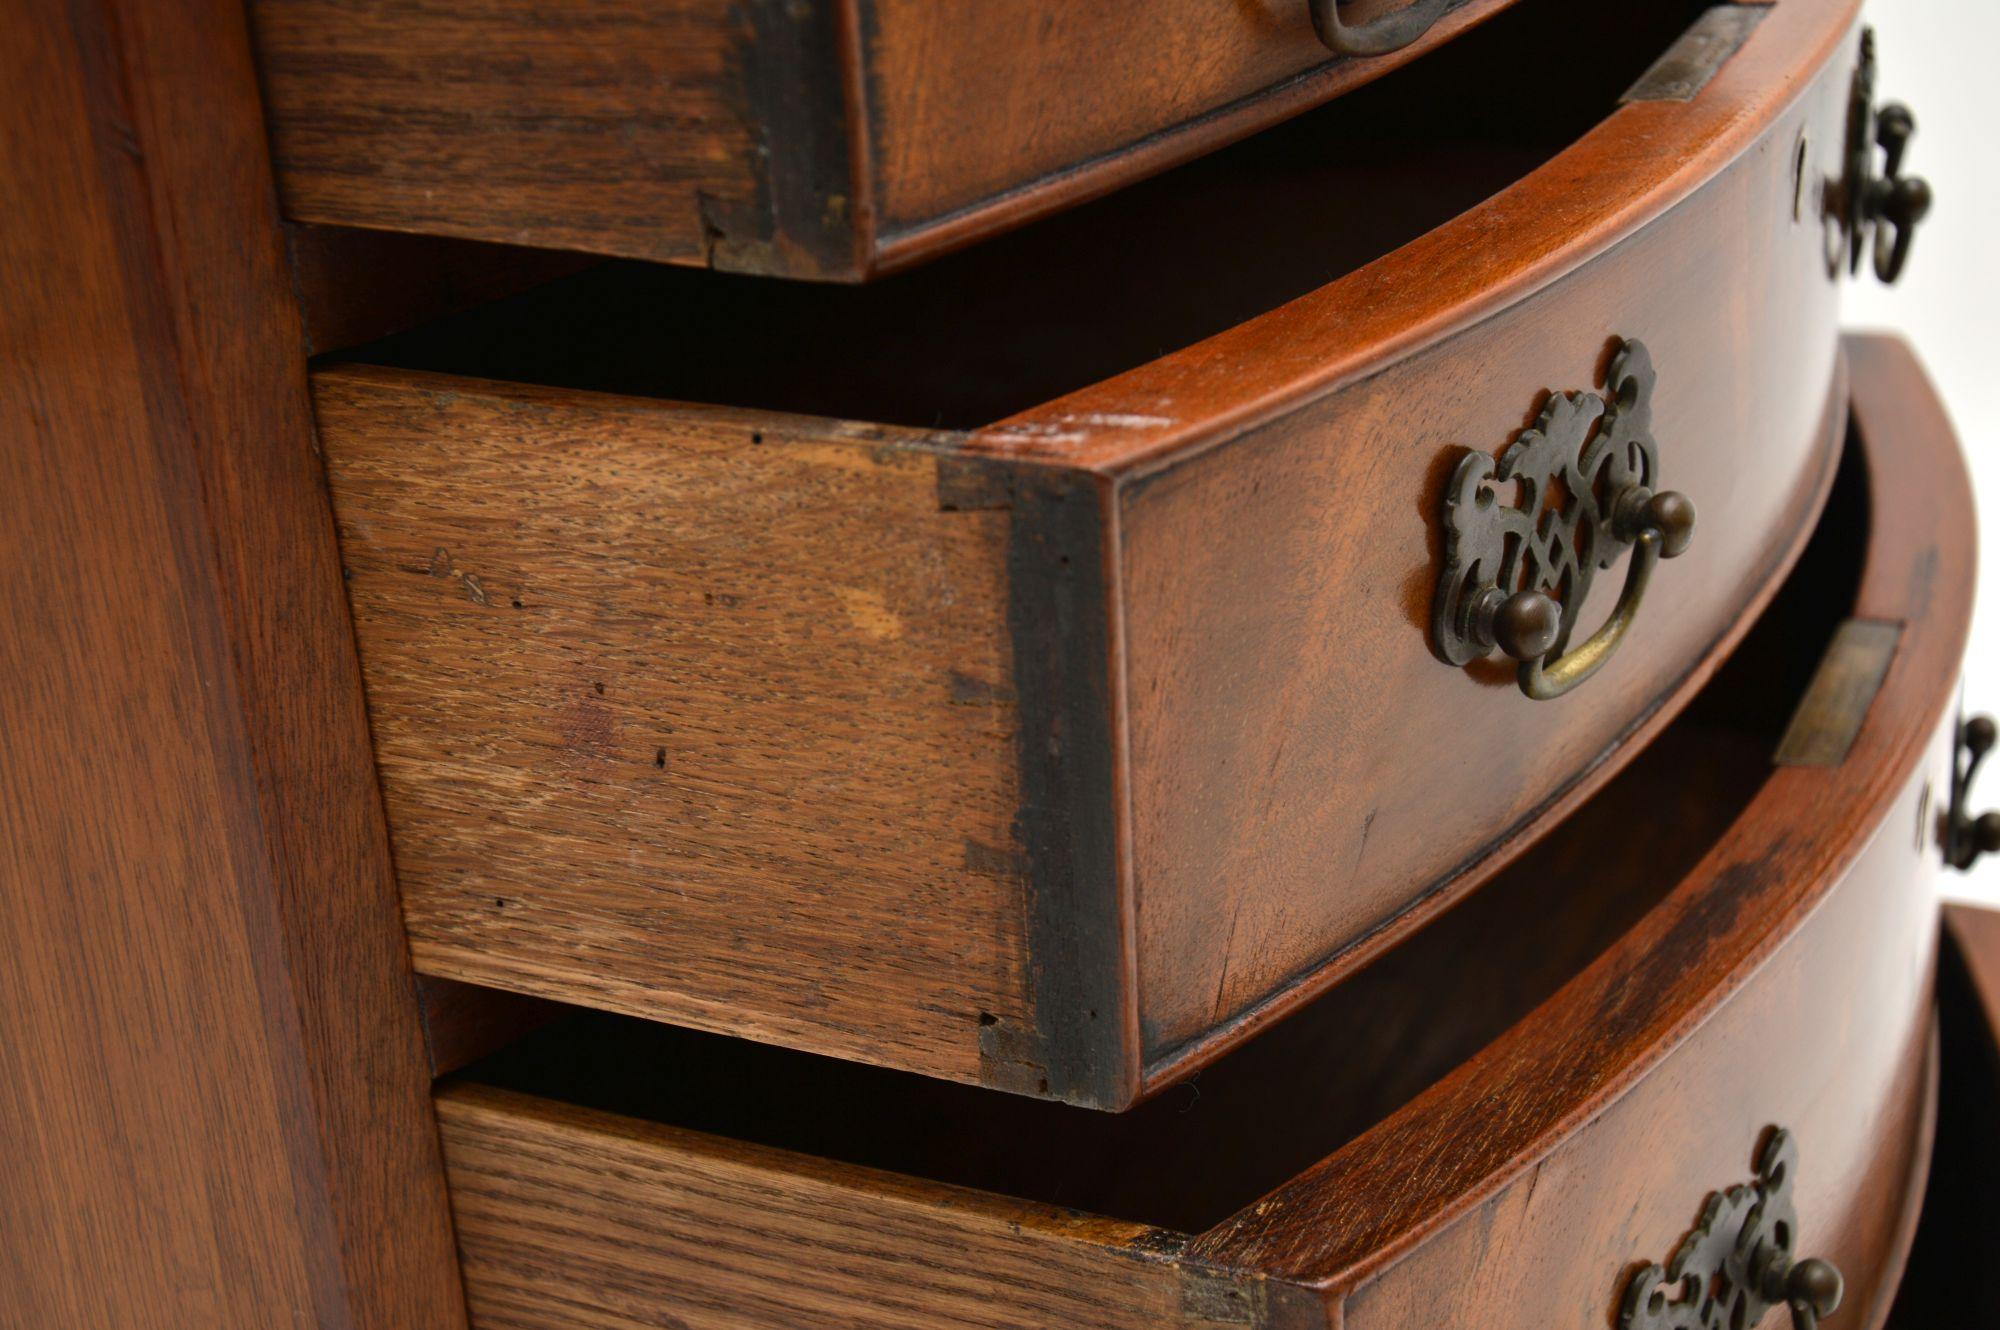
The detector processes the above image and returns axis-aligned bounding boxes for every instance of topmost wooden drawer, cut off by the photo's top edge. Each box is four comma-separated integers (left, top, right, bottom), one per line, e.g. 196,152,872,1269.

250,0,1512,280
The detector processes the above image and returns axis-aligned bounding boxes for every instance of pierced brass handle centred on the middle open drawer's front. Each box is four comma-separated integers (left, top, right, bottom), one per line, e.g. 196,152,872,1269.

1432,342,1694,700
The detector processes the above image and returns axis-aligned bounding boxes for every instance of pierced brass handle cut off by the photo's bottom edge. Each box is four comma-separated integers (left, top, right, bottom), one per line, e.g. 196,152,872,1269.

1618,1128,1842,1330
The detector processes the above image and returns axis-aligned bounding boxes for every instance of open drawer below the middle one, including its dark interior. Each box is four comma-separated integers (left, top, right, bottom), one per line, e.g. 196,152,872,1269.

438,340,1974,1330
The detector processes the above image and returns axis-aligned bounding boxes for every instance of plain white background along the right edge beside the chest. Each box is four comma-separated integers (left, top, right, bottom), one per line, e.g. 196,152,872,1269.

1842,0,2000,904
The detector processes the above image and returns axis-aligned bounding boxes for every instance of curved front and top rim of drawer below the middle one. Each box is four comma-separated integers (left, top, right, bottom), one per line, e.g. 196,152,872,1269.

1196,340,1972,1330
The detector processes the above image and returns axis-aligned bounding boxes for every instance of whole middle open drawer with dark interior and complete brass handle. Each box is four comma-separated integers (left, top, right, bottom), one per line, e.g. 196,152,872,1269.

312,0,1888,1108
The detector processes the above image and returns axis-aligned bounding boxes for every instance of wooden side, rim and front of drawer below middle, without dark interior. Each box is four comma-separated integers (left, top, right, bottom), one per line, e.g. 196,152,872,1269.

440,340,1972,1330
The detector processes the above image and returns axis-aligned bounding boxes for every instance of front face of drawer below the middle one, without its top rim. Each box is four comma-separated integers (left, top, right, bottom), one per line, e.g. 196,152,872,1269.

1342,742,1950,1330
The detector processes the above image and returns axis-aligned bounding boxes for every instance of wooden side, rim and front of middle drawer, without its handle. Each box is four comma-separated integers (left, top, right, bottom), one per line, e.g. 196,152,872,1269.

320,4,1852,1108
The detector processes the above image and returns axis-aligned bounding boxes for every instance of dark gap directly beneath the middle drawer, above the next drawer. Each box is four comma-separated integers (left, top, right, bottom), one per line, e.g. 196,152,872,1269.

450,428,1868,1232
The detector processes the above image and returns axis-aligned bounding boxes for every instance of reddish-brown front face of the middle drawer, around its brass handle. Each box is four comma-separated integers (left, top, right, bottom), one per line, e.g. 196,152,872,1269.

1118,26,1848,1080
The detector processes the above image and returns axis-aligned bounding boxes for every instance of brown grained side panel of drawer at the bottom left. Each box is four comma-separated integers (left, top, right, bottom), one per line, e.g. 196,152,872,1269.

438,1086,1232,1330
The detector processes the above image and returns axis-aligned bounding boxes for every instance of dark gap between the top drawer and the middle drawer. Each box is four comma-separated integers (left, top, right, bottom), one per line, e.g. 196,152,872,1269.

328,0,1706,428
